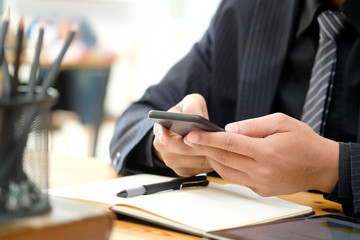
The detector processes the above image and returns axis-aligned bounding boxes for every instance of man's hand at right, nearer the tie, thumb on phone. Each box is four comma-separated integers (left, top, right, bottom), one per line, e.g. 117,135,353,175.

184,113,339,196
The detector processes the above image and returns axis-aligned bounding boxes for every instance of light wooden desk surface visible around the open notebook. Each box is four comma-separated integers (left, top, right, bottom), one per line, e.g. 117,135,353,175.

50,156,342,240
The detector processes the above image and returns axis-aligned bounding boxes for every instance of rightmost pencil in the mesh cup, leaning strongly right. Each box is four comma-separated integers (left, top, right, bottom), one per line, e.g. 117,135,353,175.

41,24,78,94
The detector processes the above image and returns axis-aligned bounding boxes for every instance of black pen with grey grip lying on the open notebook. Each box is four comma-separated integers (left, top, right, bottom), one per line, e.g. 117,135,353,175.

116,175,209,198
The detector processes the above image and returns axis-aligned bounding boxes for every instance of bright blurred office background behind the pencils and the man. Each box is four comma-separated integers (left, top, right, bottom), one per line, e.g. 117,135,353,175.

0,0,220,161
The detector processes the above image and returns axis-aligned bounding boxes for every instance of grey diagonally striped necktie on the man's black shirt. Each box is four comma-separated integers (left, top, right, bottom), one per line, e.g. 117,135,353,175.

301,11,345,135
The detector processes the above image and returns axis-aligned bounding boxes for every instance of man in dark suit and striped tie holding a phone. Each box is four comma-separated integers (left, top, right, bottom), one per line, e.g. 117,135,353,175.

110,0,360,216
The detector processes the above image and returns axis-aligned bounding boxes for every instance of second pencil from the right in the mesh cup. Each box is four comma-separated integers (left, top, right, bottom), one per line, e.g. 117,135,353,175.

26,21,45,98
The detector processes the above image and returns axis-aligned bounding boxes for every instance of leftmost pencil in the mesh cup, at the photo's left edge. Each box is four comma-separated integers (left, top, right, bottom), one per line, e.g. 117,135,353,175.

0,10,11,98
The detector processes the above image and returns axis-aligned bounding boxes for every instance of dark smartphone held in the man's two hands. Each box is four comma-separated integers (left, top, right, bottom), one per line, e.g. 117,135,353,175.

148,110,225,137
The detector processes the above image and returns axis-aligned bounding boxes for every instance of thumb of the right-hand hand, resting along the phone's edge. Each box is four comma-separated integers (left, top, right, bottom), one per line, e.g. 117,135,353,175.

225,113,290,137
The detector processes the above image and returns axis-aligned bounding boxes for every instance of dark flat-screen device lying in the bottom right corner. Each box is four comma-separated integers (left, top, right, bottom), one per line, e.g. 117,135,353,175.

203,214,360,240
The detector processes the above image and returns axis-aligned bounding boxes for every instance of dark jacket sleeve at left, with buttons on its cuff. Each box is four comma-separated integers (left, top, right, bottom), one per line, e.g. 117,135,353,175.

110,0,236,174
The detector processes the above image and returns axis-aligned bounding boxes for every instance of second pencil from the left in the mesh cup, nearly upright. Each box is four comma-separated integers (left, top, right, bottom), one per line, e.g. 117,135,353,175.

11,17,24,96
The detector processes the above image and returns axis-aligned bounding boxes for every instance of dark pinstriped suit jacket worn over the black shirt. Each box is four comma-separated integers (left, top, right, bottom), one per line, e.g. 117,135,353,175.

110,0,360,214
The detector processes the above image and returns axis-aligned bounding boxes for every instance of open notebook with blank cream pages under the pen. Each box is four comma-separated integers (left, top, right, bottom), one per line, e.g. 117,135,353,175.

49,174,313,236
